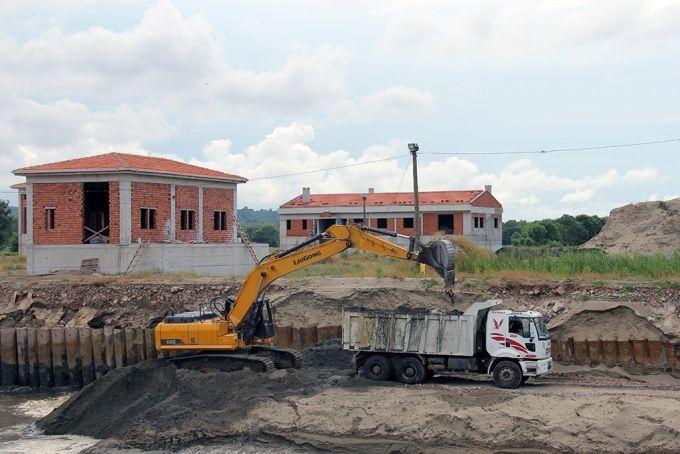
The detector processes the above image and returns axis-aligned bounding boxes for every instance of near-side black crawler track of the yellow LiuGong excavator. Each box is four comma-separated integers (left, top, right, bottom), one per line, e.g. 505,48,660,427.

166,352,277,372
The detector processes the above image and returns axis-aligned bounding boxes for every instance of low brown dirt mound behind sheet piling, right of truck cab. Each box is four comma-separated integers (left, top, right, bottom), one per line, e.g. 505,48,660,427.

550,306,665,340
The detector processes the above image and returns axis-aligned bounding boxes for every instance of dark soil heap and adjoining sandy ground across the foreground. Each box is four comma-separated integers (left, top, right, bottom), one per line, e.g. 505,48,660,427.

39,342,680,452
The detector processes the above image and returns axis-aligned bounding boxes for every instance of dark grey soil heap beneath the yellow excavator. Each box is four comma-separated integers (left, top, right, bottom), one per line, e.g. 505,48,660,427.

38,341,356,449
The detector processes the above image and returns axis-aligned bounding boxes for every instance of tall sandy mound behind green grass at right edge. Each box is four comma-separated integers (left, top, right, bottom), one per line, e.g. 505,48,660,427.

581,198,680,254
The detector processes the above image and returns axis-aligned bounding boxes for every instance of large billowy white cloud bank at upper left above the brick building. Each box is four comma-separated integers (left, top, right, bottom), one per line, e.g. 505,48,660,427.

0,0,424,119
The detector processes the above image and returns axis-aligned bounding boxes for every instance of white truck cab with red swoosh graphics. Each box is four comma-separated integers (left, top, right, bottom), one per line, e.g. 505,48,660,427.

486,310,552,382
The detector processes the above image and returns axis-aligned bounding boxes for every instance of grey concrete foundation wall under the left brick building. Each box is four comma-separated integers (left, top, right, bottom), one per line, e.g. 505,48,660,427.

25,243,269,276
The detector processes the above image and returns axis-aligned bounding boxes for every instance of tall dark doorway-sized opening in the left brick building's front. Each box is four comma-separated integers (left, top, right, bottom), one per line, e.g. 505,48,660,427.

83,181,111,244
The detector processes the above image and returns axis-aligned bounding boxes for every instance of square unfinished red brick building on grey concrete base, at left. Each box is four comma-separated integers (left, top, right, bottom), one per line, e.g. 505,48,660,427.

14,153,266,274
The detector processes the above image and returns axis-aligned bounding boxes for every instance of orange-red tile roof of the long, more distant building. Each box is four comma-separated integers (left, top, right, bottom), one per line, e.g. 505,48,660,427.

281,190,484,208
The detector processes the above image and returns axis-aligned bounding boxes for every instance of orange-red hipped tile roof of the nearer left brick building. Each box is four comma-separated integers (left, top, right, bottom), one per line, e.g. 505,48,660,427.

14,153,247,182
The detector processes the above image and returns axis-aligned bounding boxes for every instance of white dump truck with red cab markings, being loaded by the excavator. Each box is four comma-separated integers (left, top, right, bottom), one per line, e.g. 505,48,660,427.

342,300,552,388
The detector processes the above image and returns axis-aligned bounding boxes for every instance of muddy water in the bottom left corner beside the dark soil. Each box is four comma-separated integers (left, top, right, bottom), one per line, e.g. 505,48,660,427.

0,393,99,453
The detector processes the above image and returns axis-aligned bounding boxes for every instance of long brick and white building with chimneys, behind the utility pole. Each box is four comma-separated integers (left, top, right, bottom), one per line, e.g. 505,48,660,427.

279,186,503,251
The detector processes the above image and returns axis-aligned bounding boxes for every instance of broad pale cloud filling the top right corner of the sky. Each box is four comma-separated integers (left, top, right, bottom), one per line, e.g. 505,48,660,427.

374,0,680,61
